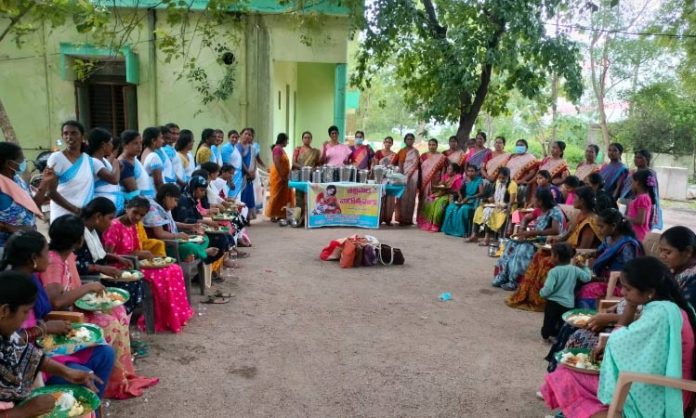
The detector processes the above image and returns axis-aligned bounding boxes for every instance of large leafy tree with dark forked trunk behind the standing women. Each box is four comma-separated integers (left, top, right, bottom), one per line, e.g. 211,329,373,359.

351,0,582,142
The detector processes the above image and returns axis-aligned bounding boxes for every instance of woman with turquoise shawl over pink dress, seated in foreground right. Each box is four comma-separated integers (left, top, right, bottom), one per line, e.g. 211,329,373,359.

541,257,696,418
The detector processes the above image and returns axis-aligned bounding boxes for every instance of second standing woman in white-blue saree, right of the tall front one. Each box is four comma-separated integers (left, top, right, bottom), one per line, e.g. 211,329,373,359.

87,128,125,213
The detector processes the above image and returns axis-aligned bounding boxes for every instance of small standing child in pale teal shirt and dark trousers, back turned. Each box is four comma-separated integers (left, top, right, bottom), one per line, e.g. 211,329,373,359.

539,242,592,341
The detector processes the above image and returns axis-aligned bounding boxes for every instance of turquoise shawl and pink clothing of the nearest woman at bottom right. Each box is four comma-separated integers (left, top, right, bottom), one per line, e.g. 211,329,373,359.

541,301,694,418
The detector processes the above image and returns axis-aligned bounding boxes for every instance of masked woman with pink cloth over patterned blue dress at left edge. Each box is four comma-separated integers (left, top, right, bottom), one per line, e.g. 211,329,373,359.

0,142,52,252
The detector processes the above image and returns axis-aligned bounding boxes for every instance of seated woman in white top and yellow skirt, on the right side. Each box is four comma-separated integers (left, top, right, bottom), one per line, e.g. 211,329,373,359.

467,167,517,247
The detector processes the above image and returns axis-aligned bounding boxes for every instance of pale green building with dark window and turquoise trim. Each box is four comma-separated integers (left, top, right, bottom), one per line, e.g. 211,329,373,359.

0,0,350,161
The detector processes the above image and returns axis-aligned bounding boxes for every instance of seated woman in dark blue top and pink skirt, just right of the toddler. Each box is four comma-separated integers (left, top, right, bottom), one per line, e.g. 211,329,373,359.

578,209,643,309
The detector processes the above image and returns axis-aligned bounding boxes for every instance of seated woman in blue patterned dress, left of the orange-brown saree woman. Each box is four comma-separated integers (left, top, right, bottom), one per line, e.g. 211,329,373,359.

492,189,565,291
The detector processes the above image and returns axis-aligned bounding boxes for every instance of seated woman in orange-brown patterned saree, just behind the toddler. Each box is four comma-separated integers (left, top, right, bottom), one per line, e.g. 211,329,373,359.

505,187,600,312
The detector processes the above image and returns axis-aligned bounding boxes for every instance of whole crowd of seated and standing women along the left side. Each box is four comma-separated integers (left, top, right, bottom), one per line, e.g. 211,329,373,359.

0,121,256,417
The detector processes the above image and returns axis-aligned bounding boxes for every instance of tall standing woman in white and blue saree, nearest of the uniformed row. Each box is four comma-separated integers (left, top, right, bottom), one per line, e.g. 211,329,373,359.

47,120,105,222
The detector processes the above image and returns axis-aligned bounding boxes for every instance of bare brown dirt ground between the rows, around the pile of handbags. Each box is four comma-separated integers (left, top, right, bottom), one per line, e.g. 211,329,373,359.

108,222,548,417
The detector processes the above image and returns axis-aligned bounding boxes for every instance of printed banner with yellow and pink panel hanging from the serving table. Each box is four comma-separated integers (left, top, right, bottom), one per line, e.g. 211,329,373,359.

307,183,382,229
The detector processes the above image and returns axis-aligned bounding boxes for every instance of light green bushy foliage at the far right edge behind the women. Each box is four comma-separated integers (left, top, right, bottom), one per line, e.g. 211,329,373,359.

611,83,696,155
